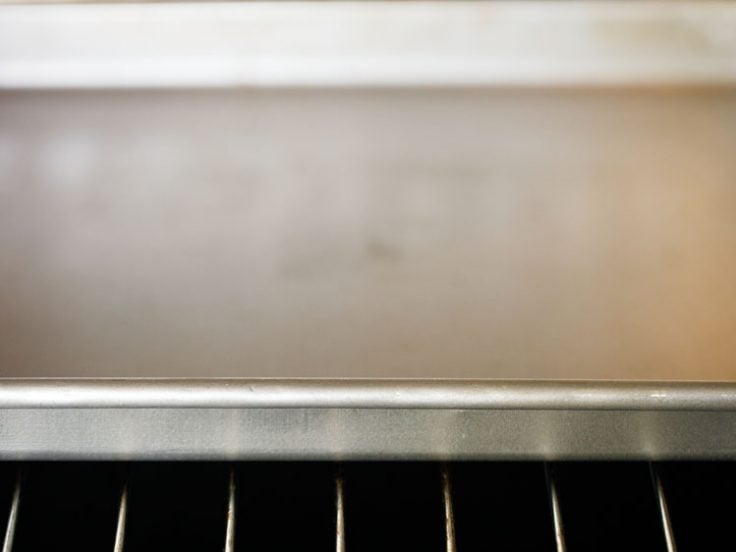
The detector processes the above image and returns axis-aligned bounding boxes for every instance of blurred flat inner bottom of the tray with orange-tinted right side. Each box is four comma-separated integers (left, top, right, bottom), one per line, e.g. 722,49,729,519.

0,90,736,381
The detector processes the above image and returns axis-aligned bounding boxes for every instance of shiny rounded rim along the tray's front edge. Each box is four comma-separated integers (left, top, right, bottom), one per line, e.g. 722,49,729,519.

0,378,736,411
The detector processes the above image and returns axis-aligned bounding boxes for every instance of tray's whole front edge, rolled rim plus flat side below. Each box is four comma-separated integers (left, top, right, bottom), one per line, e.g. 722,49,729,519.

0,379,736,459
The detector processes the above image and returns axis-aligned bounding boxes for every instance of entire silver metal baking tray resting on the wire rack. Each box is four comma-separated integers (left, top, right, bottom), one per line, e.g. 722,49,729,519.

0,2,736,458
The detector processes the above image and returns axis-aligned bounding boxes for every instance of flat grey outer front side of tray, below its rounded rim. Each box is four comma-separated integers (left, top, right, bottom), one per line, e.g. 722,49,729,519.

0,408,736,460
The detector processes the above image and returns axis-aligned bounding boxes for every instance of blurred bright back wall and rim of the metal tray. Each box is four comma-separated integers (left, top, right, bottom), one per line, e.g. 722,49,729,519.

0,1,736,88
